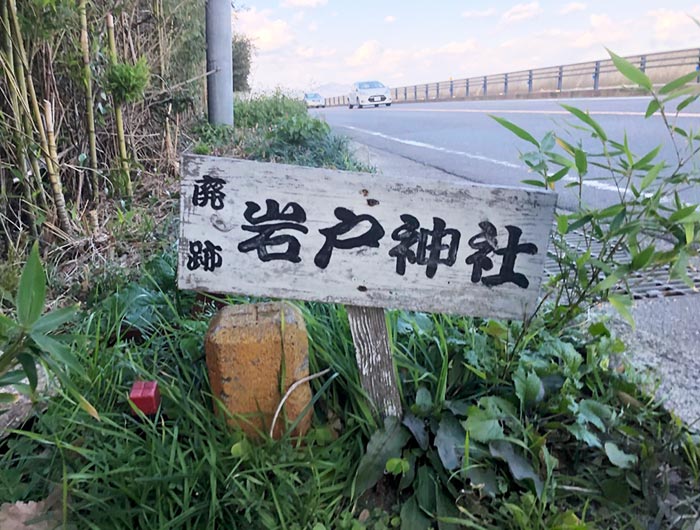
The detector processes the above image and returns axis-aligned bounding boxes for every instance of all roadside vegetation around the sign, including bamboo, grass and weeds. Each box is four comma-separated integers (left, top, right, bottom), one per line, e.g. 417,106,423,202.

0,0,700,530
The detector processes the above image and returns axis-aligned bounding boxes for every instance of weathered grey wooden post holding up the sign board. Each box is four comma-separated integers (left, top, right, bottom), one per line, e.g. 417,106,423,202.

346,305,403,418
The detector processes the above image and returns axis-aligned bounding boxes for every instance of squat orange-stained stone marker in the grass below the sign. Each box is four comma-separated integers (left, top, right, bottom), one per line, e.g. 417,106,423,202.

204,302,312,438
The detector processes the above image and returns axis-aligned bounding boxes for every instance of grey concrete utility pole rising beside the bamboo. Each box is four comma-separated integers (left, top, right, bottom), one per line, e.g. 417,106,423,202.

206,0,233,126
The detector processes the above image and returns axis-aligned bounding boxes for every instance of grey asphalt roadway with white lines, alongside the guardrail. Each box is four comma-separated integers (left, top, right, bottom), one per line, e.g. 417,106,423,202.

312,98,700,210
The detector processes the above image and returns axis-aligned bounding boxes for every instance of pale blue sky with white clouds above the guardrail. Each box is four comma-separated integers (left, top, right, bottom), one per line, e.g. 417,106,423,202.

233,0,700,96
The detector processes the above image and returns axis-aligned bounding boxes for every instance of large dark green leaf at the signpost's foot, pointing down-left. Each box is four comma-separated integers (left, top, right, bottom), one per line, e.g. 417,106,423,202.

354,416,411,496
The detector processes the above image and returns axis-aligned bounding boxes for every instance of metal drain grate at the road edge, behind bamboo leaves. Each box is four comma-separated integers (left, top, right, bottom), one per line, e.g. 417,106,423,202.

544,228,700,300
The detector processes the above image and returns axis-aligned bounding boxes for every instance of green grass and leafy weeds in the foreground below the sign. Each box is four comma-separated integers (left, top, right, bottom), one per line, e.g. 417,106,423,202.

0,251,700,530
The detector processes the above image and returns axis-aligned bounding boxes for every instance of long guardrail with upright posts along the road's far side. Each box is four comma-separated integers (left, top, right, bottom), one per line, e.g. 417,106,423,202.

326,48,700,106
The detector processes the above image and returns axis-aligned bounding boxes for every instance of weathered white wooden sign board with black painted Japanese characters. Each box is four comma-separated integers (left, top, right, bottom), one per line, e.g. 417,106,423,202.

178,155,556,319
